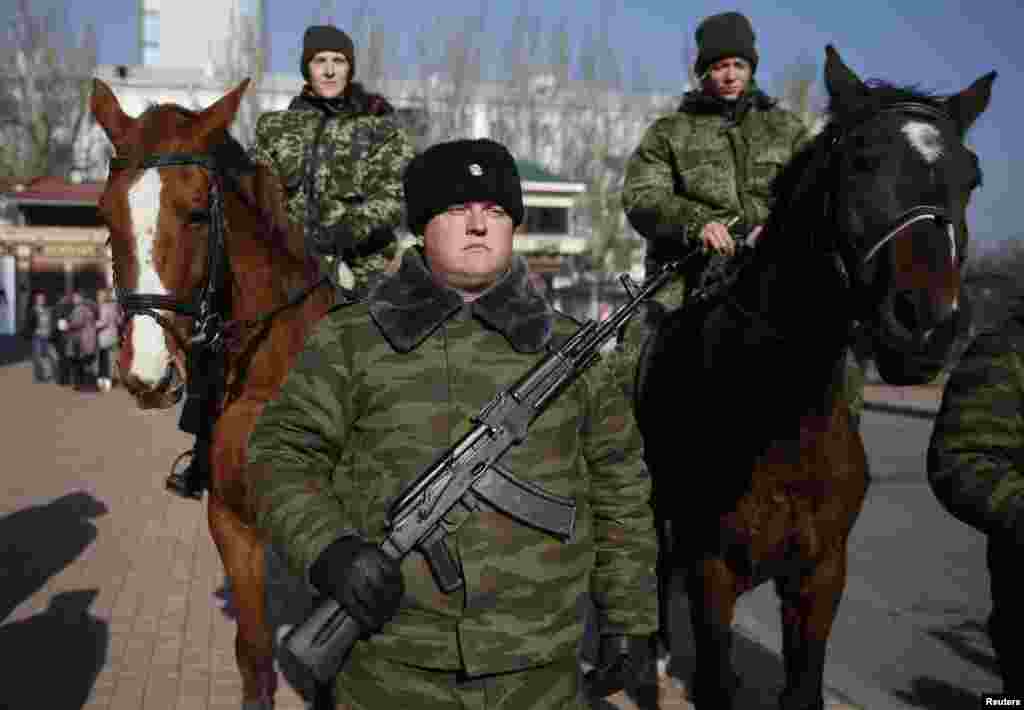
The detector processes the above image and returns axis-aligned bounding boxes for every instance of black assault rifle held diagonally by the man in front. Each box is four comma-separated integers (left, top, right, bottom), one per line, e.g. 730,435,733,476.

284,254,692,682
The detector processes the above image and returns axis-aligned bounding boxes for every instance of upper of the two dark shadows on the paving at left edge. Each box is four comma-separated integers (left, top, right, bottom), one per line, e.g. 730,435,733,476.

0,491,108,620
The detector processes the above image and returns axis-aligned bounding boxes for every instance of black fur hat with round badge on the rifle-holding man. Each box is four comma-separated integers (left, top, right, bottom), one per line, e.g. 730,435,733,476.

402,138,523,235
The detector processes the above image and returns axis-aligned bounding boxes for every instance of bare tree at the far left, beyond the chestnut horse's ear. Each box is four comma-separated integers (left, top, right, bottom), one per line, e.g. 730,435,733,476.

0,0,98,179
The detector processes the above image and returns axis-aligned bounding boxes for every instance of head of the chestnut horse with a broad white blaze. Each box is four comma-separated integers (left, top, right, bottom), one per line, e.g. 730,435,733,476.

90,80,249,409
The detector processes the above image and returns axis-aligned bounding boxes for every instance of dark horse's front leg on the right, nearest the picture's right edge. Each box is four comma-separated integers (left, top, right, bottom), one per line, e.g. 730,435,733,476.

775,549,846,710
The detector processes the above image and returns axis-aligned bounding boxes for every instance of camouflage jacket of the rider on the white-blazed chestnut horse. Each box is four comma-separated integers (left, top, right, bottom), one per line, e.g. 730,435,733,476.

251,83,413,290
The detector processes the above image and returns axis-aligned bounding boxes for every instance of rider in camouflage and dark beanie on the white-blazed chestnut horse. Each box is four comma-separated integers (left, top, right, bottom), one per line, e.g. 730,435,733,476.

252,25,413,300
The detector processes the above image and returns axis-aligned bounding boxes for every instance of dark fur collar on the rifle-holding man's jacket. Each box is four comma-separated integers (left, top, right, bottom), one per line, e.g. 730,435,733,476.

369,248,554,352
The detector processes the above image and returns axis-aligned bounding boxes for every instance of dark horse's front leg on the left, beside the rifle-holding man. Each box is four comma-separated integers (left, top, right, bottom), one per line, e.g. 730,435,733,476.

687,557,739,710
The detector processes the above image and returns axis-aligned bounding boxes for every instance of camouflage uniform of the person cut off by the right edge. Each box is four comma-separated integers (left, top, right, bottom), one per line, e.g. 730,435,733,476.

928,311,1024,697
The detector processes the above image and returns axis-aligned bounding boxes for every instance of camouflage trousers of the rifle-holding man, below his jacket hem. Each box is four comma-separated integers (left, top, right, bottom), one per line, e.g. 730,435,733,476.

335,644,589,710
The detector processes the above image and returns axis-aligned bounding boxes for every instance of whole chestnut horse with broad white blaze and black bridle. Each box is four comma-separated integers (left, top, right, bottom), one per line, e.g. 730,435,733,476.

91,80,333,710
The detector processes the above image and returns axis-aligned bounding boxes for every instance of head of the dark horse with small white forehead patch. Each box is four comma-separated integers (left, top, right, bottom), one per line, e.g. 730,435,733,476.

823,45,996,384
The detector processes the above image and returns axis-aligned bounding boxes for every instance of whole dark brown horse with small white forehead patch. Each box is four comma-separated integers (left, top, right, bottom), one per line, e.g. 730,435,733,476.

636,46,995,710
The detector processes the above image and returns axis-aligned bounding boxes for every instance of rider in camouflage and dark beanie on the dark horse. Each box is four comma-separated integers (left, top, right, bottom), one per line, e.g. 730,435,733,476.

618,12,810,663
